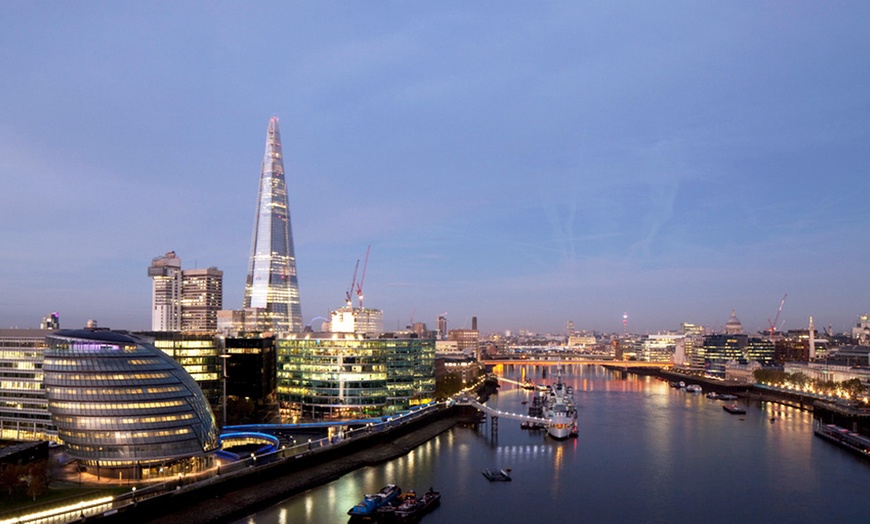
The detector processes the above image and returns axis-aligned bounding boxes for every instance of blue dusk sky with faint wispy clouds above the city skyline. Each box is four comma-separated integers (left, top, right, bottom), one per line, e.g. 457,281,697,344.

0,1,870,332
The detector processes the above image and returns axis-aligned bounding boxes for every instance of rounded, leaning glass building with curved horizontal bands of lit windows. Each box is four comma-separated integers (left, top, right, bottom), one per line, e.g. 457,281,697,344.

43,330,219,467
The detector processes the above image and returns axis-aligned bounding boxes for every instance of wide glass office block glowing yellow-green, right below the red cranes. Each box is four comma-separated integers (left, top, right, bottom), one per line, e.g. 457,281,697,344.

276,333,435,421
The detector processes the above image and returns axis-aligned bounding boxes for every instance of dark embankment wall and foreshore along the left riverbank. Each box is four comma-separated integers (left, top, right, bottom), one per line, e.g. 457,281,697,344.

97,406,468,524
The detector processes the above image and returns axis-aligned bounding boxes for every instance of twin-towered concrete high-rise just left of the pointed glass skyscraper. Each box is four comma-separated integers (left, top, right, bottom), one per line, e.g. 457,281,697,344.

148,251,223,332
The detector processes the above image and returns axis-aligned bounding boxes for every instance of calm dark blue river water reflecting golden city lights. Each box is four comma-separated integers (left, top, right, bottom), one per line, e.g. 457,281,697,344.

239,365,870,524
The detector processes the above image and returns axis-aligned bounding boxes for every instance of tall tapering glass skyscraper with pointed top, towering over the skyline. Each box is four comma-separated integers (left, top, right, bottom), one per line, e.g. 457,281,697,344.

245,116,302,333
